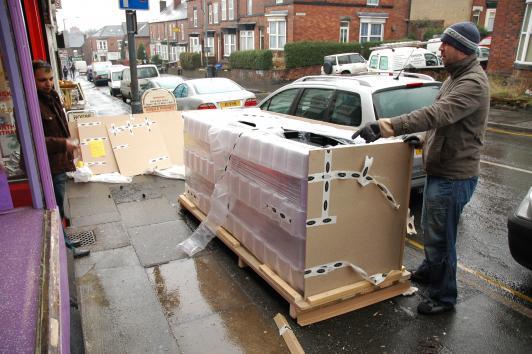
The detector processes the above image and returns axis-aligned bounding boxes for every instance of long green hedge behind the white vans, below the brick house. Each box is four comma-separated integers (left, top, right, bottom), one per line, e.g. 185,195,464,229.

284,41,382,69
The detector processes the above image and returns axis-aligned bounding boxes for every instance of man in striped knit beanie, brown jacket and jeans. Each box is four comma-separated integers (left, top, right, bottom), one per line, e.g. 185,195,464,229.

354,22,490,315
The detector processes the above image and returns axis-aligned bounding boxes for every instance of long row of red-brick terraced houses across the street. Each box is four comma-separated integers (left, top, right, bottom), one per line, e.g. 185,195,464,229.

150,0,410,62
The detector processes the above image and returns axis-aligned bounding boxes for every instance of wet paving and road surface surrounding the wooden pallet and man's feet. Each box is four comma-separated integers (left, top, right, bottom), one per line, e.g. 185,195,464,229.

67,76,532,353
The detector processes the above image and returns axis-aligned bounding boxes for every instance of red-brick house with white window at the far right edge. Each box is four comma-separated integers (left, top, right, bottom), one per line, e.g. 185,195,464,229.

488,0,532,78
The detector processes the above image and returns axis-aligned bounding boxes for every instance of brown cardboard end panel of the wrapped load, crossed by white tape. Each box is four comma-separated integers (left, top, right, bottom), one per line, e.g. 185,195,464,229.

304,142,412,296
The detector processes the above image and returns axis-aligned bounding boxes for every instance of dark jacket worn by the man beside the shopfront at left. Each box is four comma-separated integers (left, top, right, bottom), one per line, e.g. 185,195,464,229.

38,90,76,175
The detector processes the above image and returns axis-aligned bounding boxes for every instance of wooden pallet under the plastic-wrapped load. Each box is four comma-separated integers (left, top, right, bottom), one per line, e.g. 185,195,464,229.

178,195,410,326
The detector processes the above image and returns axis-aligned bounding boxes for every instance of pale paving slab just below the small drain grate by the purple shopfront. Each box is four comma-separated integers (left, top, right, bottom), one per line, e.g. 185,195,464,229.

75,246,140,278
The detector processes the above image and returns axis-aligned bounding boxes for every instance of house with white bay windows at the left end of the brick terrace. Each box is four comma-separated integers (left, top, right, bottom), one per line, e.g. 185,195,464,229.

149,0,189,67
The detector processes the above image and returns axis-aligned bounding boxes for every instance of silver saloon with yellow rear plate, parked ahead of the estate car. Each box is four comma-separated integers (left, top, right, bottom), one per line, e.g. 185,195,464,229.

173,77,257,110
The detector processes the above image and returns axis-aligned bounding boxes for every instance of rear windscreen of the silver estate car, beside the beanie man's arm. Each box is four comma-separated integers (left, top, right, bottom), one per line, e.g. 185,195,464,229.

373,85,440,118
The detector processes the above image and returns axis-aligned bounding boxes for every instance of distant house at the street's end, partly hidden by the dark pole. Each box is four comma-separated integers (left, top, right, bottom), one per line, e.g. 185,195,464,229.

83,22,150,64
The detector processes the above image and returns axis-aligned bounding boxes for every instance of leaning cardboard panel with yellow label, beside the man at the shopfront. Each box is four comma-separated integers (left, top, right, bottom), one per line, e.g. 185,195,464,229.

76,116,127,174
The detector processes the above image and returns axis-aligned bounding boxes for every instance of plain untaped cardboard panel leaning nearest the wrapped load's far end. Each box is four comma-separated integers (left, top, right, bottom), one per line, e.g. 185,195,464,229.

133,111,184,165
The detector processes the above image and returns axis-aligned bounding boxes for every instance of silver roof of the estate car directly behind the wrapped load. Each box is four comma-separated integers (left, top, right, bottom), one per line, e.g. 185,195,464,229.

287,73,439,92
